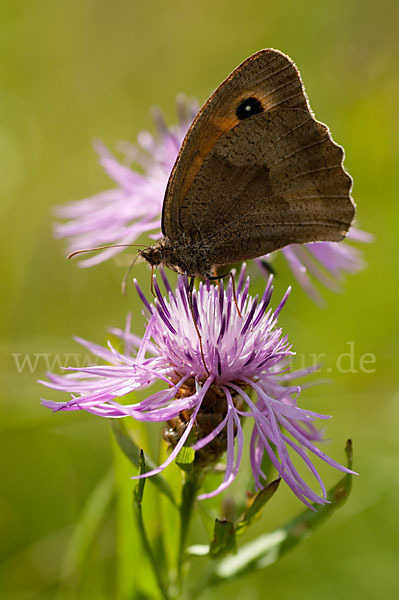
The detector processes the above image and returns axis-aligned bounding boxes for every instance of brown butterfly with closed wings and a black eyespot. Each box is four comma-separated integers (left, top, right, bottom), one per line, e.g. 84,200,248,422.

140,49,355,278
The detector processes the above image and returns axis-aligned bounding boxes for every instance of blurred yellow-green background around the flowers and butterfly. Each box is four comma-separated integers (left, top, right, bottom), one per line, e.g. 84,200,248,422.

0,0,399,600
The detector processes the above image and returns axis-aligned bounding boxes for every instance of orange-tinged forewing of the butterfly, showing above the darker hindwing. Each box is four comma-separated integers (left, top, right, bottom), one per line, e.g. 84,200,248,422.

162,49,309,240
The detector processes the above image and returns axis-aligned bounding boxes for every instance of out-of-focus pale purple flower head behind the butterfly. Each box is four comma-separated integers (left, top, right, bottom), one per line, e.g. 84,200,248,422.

55,96,371,302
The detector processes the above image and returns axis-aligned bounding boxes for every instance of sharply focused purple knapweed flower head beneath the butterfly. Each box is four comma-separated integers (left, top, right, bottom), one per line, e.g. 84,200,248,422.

39,267,354,506
